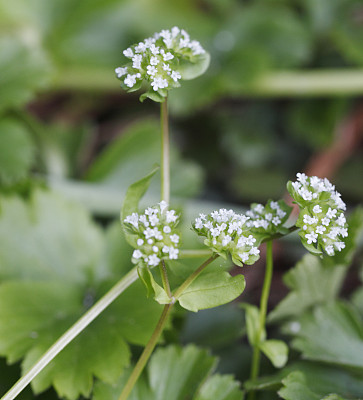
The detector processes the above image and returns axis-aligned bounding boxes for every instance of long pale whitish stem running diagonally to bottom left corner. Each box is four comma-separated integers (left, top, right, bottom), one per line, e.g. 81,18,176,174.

1,268,138,400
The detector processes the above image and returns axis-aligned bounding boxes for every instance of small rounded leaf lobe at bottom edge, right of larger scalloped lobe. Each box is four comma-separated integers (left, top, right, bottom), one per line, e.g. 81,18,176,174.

194,374,243,400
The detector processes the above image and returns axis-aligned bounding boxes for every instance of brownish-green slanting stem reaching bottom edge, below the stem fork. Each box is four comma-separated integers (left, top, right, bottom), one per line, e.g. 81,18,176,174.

119,304,173,400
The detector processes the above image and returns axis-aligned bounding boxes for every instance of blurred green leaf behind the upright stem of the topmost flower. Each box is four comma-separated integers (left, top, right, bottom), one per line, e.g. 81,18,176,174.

87,119,204,200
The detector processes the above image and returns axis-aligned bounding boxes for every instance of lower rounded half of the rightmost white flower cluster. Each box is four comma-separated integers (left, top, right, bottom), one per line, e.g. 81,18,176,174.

296,204,348,256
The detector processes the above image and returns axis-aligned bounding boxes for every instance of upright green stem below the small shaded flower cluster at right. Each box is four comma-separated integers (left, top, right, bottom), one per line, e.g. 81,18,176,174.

249,241,273,400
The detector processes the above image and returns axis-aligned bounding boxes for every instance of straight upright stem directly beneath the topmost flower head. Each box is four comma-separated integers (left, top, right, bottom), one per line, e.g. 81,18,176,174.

160,98,170,204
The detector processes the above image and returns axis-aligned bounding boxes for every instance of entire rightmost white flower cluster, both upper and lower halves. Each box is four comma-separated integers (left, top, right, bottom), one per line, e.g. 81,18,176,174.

288,173,348,256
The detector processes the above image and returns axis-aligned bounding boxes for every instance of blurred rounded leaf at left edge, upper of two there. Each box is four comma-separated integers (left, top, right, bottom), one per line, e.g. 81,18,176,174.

0,34,50,112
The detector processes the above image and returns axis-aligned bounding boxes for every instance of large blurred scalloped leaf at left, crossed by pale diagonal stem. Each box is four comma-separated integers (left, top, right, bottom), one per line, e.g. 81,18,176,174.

0,191,161,399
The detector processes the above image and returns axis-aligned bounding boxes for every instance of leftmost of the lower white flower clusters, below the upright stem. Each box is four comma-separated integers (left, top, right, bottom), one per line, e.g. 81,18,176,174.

123,201,180,267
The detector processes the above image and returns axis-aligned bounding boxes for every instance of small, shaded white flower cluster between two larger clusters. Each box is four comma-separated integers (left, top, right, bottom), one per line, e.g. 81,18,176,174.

246,200,291,234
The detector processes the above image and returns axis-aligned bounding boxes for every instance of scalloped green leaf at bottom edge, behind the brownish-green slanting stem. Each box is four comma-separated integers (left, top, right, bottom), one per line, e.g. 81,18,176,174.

93,345,243,400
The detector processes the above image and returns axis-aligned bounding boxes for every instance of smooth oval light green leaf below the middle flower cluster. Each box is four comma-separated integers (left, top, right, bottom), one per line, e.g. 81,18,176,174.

178,271,246,312
